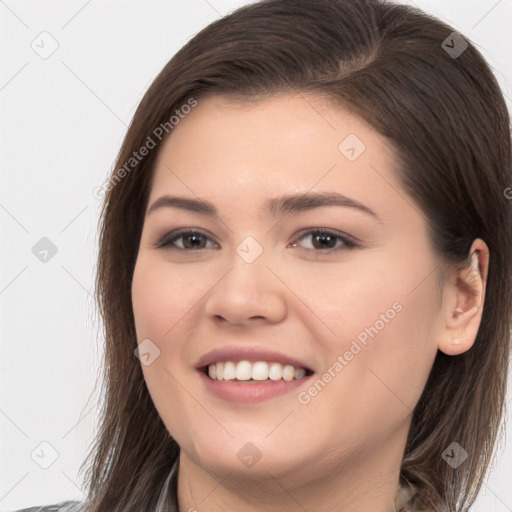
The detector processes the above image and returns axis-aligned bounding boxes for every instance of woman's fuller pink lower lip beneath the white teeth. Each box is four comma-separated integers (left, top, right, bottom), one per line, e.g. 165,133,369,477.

199,370,311,403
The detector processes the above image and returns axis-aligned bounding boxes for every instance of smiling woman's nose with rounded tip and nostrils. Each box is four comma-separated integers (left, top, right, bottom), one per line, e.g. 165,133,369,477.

205,246,287,325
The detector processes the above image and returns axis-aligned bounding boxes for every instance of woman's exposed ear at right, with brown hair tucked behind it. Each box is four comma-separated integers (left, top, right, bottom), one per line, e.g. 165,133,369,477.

438,238,489,356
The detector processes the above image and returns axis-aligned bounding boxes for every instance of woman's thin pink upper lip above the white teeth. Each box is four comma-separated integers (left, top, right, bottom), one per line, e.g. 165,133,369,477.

196,346,313,372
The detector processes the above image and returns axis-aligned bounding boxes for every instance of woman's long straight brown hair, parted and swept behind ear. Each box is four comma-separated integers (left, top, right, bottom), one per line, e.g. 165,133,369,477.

81,0,512,512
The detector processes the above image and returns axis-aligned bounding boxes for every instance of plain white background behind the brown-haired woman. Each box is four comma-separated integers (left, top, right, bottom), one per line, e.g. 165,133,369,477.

0,0,512,512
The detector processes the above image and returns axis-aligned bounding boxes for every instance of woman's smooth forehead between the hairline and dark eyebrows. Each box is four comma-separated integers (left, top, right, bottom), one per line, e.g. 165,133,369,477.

144,93,425,231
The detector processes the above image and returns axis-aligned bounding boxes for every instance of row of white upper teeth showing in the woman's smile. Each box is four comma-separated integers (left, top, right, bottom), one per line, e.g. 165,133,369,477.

208,361,306,381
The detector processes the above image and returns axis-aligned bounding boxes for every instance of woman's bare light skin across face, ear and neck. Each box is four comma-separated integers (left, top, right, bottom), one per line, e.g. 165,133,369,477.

132,94,489,512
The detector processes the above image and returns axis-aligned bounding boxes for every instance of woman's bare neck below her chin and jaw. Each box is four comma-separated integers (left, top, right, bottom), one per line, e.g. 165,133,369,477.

178,428,405,512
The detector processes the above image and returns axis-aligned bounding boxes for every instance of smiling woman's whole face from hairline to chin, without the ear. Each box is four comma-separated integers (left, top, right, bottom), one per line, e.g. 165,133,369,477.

132,94,442,482
